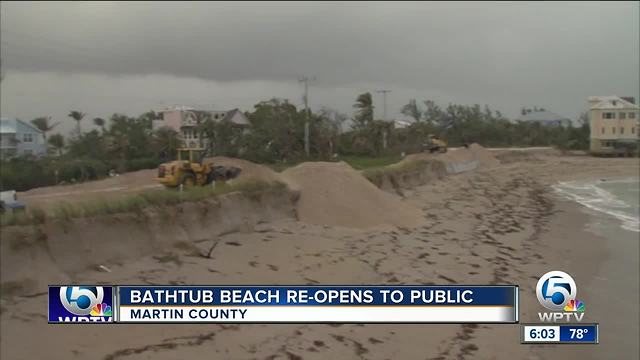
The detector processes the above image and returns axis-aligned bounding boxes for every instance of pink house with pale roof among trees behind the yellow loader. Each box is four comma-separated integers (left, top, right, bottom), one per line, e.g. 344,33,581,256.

153,106,251,147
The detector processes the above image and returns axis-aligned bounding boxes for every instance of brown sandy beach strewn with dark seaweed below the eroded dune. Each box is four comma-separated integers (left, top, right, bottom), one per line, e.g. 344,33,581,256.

0,150,640,360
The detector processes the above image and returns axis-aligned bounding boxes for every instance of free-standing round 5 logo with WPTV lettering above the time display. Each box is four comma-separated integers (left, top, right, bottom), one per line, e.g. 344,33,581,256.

536,271,585,322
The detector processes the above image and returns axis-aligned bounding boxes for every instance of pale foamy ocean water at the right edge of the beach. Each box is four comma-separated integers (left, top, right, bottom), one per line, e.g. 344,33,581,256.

553,177,640,233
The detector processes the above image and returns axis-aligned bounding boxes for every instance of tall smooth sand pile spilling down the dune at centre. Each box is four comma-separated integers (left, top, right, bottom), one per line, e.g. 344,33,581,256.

282,162,423,228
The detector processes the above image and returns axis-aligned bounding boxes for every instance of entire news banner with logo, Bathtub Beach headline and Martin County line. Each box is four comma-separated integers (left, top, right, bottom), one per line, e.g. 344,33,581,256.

49,286,518,323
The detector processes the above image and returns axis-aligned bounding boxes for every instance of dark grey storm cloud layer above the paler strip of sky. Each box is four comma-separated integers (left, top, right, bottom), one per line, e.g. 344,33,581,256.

2,2,639,86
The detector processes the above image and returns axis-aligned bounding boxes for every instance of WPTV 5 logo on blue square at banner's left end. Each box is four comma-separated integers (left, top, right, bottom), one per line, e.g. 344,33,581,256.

49,286,113,323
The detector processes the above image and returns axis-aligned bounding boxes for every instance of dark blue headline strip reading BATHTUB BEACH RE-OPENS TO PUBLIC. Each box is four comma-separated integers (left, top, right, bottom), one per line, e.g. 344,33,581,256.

118,286,517,307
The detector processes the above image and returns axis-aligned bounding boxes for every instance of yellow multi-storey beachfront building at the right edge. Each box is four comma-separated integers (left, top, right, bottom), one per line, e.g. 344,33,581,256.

588,96,640,156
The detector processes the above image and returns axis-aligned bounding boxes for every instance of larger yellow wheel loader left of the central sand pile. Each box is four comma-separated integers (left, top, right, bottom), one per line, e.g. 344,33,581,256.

156,148,241,188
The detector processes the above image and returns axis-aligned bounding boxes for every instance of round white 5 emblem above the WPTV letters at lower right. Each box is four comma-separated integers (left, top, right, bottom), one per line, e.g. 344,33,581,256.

536,271,578,311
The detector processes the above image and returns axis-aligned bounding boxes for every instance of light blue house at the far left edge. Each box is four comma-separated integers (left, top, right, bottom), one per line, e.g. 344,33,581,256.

0,118,47,160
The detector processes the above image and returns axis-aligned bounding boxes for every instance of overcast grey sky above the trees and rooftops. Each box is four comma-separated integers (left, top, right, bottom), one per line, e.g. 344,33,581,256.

0,2,640,131
